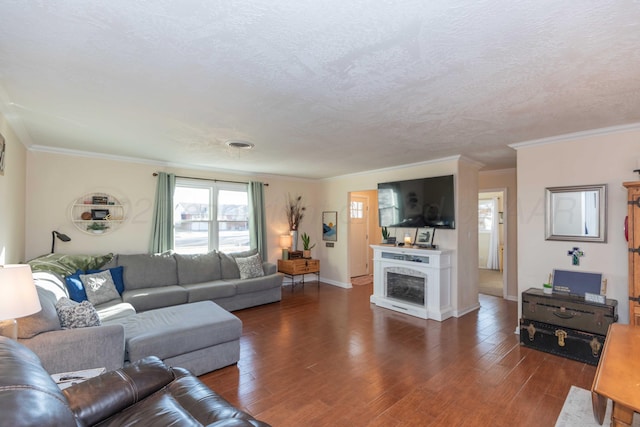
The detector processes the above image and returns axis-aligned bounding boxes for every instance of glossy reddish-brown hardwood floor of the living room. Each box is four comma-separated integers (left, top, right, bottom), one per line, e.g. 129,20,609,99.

200,283,595,427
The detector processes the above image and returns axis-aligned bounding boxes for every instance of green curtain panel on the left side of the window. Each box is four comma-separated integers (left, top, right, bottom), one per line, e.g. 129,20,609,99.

149,172,176,254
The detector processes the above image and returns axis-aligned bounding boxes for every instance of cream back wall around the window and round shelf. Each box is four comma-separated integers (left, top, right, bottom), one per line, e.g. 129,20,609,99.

23,151,322,262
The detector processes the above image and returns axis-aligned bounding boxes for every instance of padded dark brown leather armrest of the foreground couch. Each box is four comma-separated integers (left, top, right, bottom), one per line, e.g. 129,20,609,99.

63,356,174,425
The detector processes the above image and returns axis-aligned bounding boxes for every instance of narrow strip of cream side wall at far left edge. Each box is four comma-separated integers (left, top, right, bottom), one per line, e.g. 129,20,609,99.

0,114,27,265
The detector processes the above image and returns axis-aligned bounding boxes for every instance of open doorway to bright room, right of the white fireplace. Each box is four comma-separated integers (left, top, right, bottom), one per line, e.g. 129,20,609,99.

478,189,507,298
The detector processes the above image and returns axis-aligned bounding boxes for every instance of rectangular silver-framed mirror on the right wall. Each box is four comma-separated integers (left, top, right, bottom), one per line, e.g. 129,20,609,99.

545,184,607,243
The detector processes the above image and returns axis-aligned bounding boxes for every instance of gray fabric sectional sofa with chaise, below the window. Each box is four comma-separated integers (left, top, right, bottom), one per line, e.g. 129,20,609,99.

18,251,283,375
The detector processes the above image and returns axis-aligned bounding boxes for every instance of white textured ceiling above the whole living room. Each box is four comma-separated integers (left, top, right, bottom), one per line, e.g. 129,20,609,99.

0,0,640,178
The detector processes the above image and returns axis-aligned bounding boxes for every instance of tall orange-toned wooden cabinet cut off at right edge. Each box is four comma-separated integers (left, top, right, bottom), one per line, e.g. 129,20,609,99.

623,181,640,326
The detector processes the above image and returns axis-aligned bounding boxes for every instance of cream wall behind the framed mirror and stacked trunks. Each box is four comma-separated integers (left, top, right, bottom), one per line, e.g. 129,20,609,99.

517,129,640,323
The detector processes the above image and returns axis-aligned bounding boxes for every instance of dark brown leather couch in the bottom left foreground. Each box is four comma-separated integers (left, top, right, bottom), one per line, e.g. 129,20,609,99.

0,337,269,427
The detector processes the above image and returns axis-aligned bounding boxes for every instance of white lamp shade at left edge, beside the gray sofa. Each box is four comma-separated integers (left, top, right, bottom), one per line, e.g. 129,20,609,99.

0,264,41,320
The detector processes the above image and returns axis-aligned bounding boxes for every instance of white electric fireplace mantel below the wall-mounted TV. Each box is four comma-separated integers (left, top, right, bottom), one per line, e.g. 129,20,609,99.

370,245,453,321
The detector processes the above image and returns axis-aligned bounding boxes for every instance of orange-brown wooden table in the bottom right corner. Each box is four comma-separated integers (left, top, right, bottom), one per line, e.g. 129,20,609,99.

591,323,640,427
